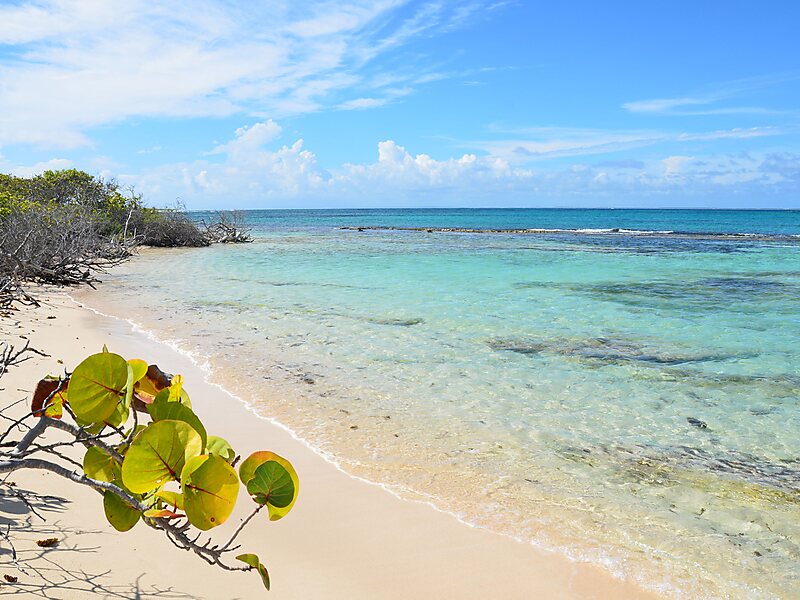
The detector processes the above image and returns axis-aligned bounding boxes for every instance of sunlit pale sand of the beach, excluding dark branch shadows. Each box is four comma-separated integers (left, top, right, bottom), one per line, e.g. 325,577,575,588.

0,291,656,598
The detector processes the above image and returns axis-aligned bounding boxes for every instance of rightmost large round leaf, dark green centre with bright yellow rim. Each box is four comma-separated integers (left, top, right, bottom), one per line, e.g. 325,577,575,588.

239,451,300,521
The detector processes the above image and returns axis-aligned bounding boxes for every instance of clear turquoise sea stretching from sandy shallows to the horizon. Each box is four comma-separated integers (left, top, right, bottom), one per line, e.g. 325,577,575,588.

86,210,800,597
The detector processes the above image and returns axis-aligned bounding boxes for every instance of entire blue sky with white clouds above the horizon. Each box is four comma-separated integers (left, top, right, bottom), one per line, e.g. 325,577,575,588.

0,0,800,209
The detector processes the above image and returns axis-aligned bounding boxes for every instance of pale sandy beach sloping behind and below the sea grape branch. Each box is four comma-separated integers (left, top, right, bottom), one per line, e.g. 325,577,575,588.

0,290,664,599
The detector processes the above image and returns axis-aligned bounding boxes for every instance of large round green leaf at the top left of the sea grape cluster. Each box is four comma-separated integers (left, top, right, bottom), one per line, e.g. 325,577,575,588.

69,352,128,423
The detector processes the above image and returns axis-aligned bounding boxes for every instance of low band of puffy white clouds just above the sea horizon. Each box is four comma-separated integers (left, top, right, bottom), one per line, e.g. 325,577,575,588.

121,124,800,208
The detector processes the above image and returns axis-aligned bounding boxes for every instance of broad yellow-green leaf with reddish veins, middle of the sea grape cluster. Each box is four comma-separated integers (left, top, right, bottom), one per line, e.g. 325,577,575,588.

122,420,203,494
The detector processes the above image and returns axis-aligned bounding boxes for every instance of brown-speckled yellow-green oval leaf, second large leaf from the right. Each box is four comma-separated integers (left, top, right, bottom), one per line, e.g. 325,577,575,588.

181,454,239,531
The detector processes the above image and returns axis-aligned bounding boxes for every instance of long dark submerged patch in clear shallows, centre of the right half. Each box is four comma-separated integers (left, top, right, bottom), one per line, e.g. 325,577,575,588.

488,338,742,365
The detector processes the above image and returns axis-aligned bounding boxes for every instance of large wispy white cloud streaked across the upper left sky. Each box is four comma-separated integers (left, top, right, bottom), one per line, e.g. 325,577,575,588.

0,0,494,147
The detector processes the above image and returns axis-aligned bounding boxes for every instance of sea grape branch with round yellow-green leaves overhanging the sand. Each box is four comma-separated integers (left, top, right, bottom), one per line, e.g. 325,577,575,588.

0,347,299,589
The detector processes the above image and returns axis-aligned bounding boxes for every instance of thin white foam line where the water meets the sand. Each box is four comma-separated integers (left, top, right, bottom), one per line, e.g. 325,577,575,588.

66,294,680,597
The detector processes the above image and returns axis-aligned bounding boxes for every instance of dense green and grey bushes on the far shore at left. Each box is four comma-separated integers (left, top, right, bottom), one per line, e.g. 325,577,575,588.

0,169,250,309
